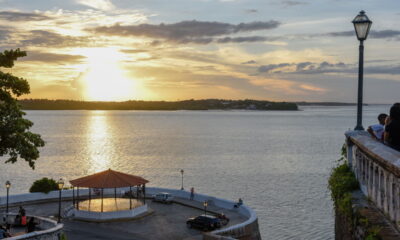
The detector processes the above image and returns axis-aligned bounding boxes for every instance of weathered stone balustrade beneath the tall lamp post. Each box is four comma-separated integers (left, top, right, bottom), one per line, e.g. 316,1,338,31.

345,131,400,228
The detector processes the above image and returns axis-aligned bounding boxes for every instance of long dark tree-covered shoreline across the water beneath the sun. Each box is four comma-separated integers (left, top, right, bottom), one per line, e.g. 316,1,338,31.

19,99,298,111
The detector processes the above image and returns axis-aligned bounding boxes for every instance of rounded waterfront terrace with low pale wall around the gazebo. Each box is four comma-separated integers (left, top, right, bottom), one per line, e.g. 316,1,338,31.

0,187,261,240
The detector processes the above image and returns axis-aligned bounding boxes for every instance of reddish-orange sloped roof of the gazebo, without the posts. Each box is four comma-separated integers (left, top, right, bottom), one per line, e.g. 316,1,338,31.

69,169,149,188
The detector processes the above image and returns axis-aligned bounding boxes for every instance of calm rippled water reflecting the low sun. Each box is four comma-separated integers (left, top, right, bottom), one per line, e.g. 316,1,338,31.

0,106,390,240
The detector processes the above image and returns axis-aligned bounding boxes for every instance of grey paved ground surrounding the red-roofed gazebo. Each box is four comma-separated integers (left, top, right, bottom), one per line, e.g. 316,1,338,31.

3,198,246,240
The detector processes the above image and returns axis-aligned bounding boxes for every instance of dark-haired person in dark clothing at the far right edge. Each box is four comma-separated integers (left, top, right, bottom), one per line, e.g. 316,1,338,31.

384,103,400,151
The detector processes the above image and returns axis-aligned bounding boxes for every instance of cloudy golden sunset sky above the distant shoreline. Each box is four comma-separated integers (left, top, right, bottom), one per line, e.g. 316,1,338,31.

0,0,400,103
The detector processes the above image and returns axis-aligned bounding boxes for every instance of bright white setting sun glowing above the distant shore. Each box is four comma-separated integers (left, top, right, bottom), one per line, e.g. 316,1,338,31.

81,48,137,101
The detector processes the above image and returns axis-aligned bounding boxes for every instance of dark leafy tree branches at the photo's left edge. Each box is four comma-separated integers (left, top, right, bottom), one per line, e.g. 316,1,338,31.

0,49,44,169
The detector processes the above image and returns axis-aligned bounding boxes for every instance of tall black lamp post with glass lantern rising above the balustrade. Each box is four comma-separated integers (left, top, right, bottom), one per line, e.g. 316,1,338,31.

352,11,372,130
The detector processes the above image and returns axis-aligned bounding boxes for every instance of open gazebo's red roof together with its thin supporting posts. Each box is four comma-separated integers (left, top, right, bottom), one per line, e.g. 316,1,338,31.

69,169,149,212
